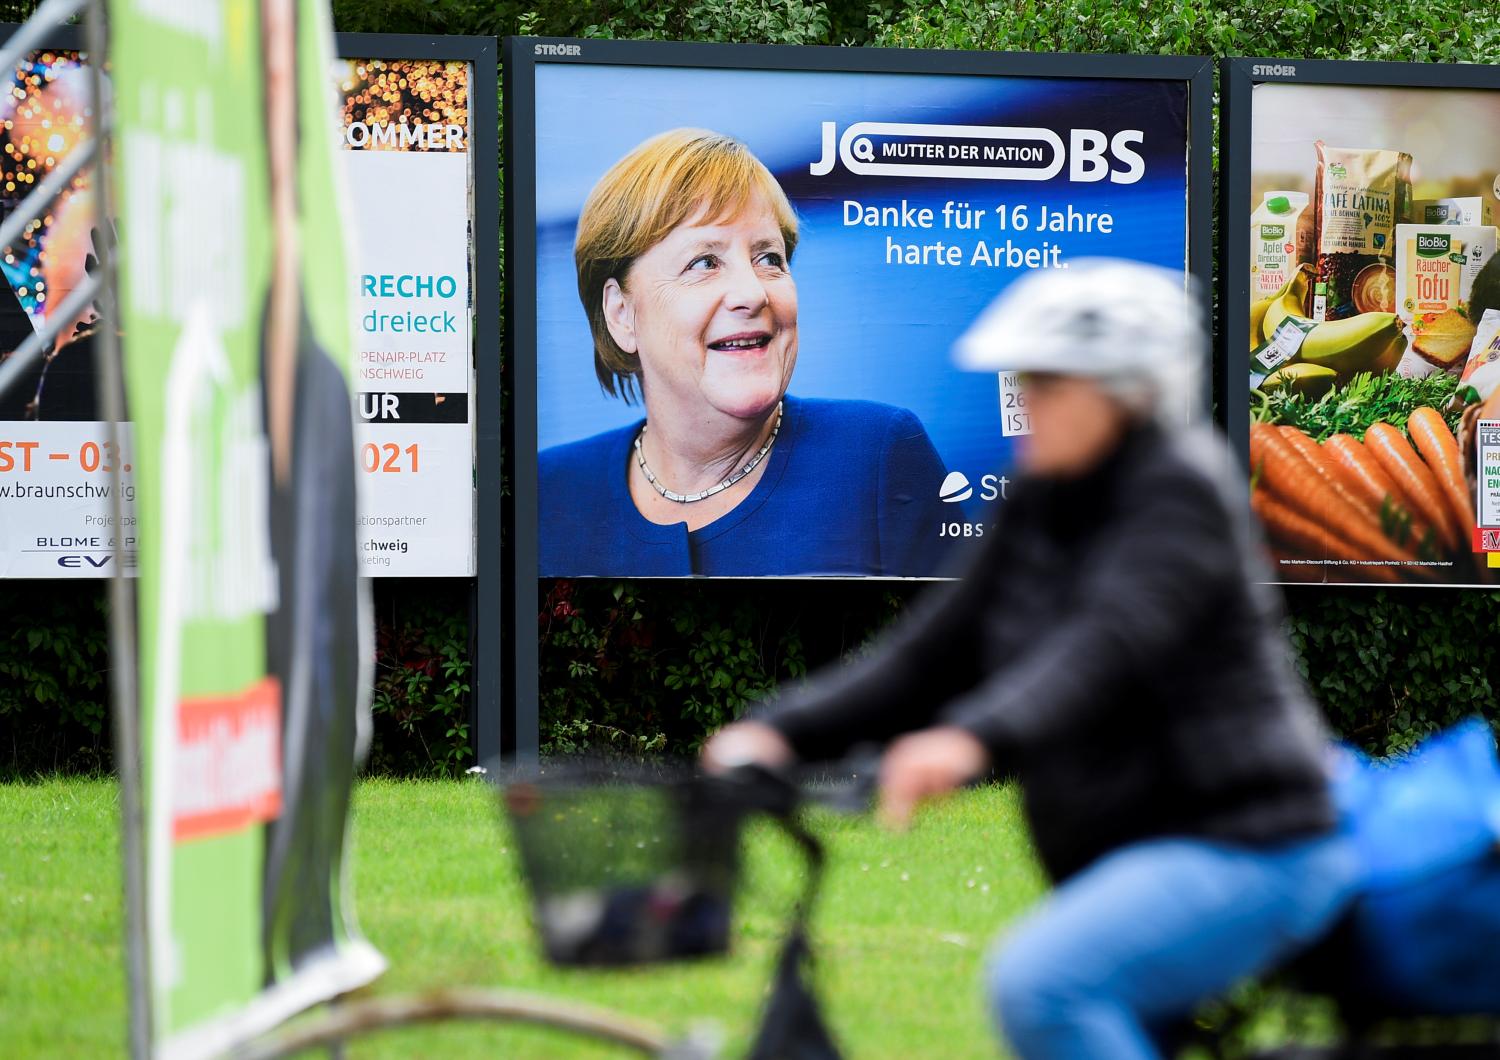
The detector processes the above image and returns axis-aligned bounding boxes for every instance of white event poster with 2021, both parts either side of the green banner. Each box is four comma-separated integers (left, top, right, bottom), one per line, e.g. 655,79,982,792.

0,51,474,577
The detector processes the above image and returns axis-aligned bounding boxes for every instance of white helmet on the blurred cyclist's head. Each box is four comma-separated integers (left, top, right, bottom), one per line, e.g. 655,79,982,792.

954,258,1206,423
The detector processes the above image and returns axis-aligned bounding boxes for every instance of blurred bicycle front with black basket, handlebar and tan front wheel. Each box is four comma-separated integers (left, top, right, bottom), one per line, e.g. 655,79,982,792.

234,759,873,1060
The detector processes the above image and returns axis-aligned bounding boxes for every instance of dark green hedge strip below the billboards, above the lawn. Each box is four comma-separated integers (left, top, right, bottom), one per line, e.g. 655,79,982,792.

0,580,1500,777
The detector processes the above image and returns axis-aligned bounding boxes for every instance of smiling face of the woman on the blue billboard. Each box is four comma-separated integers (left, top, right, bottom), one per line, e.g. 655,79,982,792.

603,195,797,423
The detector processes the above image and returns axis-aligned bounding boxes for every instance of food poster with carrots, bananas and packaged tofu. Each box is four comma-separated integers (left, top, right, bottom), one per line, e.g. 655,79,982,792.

1230,82,1500,585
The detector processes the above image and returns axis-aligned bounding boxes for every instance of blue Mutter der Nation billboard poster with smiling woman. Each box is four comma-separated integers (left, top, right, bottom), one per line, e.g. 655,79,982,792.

534,62,1190,577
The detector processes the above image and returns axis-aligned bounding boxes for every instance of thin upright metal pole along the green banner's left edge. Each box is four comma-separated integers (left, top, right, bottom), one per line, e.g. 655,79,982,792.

86,0,152,1060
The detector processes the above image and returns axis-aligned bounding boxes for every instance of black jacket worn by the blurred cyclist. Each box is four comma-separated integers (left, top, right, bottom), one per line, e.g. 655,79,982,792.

761,427,1334,879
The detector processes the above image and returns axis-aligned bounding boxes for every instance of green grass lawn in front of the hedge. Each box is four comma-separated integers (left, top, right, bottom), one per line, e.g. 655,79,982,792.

0,780,1043,1060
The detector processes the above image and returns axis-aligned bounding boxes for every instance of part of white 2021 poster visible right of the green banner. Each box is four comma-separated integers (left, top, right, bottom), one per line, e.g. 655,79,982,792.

338,58,474,577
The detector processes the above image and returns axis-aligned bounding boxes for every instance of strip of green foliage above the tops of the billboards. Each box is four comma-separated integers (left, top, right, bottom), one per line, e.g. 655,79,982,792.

333,0,1500,63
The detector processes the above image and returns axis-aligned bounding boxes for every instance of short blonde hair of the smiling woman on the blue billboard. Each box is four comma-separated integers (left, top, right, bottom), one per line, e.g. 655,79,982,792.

573,129,797,402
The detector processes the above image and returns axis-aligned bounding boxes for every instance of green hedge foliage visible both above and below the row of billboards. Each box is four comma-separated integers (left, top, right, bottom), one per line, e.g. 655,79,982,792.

0,0,1500,772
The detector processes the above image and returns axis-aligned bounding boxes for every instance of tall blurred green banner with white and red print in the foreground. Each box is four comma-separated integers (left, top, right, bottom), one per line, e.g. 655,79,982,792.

110,0,384,1057
